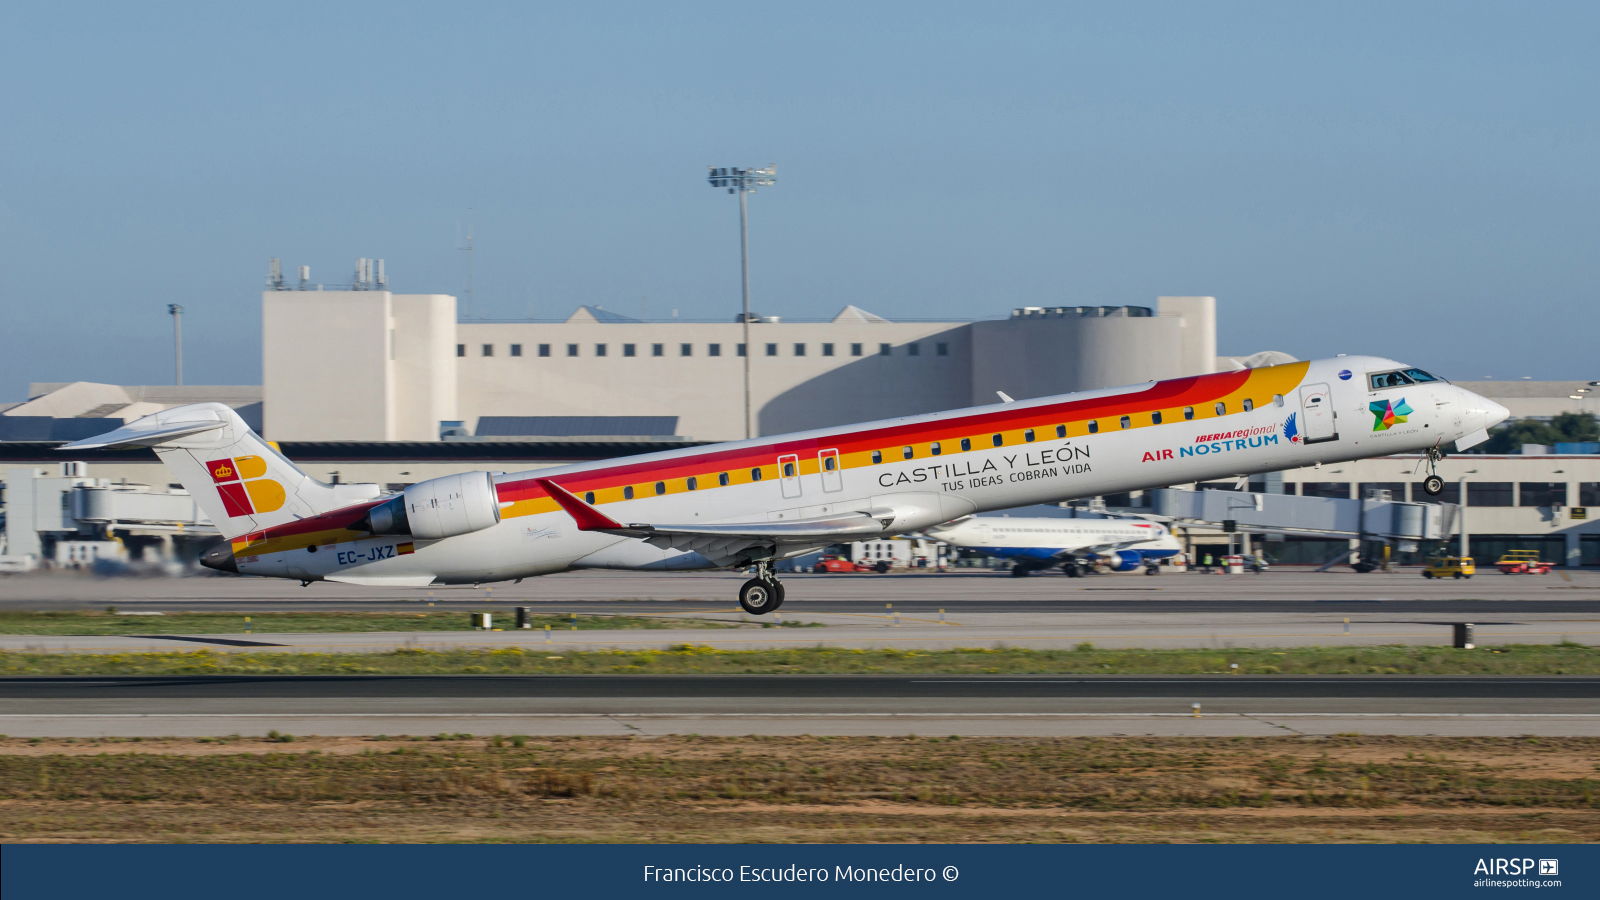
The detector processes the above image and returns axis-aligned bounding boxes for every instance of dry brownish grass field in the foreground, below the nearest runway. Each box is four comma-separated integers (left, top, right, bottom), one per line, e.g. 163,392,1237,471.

0,735,1600,842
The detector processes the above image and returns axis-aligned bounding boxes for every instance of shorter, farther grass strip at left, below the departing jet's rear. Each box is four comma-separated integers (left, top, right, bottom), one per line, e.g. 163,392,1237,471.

0,604,748,636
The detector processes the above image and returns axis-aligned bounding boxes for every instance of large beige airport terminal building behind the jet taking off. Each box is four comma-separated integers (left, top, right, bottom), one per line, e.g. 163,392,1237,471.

0,261,1600,565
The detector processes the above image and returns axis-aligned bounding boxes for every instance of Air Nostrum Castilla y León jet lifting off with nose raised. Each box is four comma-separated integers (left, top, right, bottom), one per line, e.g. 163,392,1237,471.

62,357,1507,613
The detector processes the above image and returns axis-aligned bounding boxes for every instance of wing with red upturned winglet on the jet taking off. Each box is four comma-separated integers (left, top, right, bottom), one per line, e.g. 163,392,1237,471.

534,479,894,559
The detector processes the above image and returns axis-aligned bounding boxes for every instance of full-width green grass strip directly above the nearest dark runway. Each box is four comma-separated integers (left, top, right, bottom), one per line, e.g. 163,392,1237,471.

0,644,1600,677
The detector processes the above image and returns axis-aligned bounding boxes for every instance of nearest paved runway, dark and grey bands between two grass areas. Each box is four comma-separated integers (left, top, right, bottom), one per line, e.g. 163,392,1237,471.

0,676,1600,737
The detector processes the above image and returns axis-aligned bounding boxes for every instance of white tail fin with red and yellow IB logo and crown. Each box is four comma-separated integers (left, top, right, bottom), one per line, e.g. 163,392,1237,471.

59,404,378,538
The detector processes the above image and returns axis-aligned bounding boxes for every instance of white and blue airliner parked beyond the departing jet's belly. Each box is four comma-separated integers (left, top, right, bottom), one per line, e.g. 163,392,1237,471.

923,516,1184,578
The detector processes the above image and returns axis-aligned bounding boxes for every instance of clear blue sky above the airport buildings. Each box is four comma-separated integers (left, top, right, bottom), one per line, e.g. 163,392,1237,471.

0,0,1600,399
